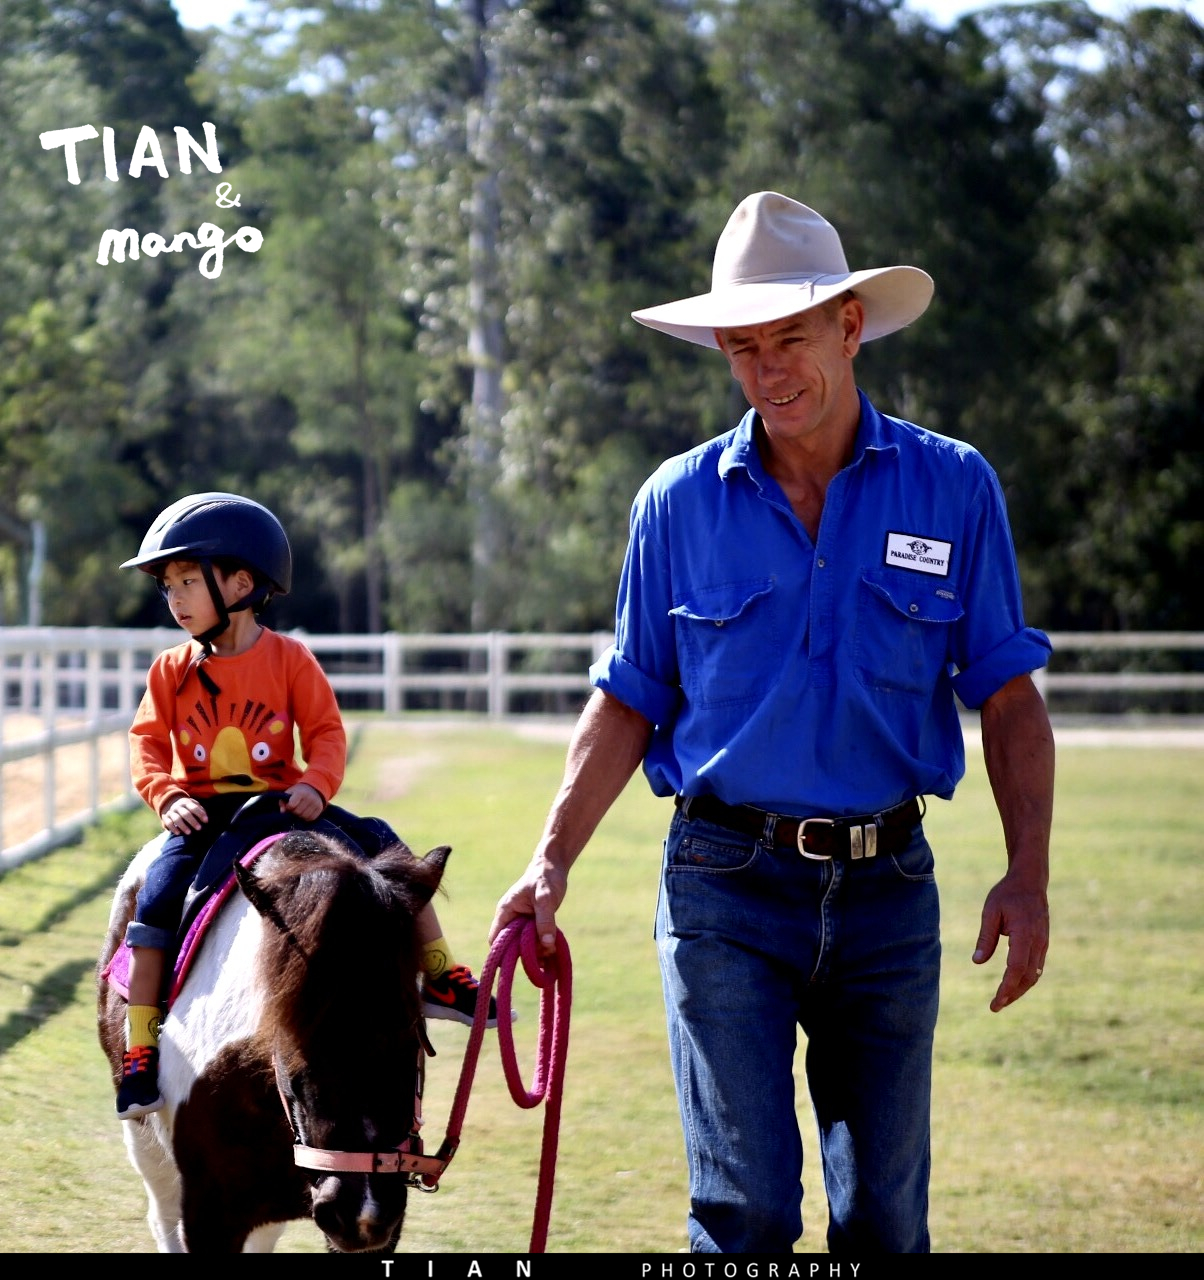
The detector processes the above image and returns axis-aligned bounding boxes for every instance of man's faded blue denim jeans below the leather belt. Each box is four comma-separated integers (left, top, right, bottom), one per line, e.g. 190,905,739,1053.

656,813,940,1258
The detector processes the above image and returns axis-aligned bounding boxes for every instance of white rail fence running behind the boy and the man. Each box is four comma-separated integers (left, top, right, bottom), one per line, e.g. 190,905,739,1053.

0,627,1204,872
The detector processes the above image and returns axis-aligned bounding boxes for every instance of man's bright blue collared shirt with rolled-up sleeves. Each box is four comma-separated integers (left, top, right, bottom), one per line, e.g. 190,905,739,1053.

590,396,1050,817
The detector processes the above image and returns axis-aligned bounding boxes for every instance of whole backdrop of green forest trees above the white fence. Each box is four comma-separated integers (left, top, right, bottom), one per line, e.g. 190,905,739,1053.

0,0,1204,631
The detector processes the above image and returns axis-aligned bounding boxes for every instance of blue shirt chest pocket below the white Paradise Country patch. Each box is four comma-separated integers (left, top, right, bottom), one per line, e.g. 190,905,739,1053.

853,570,963,695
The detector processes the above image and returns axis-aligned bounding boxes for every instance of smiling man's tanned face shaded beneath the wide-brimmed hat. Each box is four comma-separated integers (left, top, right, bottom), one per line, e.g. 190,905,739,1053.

715,298,864,444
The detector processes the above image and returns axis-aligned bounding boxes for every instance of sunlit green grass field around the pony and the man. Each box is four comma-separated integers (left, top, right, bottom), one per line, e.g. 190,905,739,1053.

0,719,1204,1253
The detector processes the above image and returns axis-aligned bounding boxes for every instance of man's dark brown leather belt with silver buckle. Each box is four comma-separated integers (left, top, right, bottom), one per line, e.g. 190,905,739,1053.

673,796,924,861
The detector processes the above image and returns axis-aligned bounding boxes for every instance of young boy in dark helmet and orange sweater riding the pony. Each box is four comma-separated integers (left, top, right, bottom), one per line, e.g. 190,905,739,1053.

116,493,496,1120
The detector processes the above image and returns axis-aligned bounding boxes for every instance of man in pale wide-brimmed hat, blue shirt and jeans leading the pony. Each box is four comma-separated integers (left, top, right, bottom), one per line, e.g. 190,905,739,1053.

491,192,1053,1257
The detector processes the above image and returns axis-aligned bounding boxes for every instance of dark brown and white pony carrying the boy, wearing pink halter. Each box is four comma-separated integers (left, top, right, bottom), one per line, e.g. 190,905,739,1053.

97,831,450,1253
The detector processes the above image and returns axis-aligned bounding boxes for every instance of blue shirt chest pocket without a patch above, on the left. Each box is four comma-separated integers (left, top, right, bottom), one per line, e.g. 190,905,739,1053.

669,579,780,707
